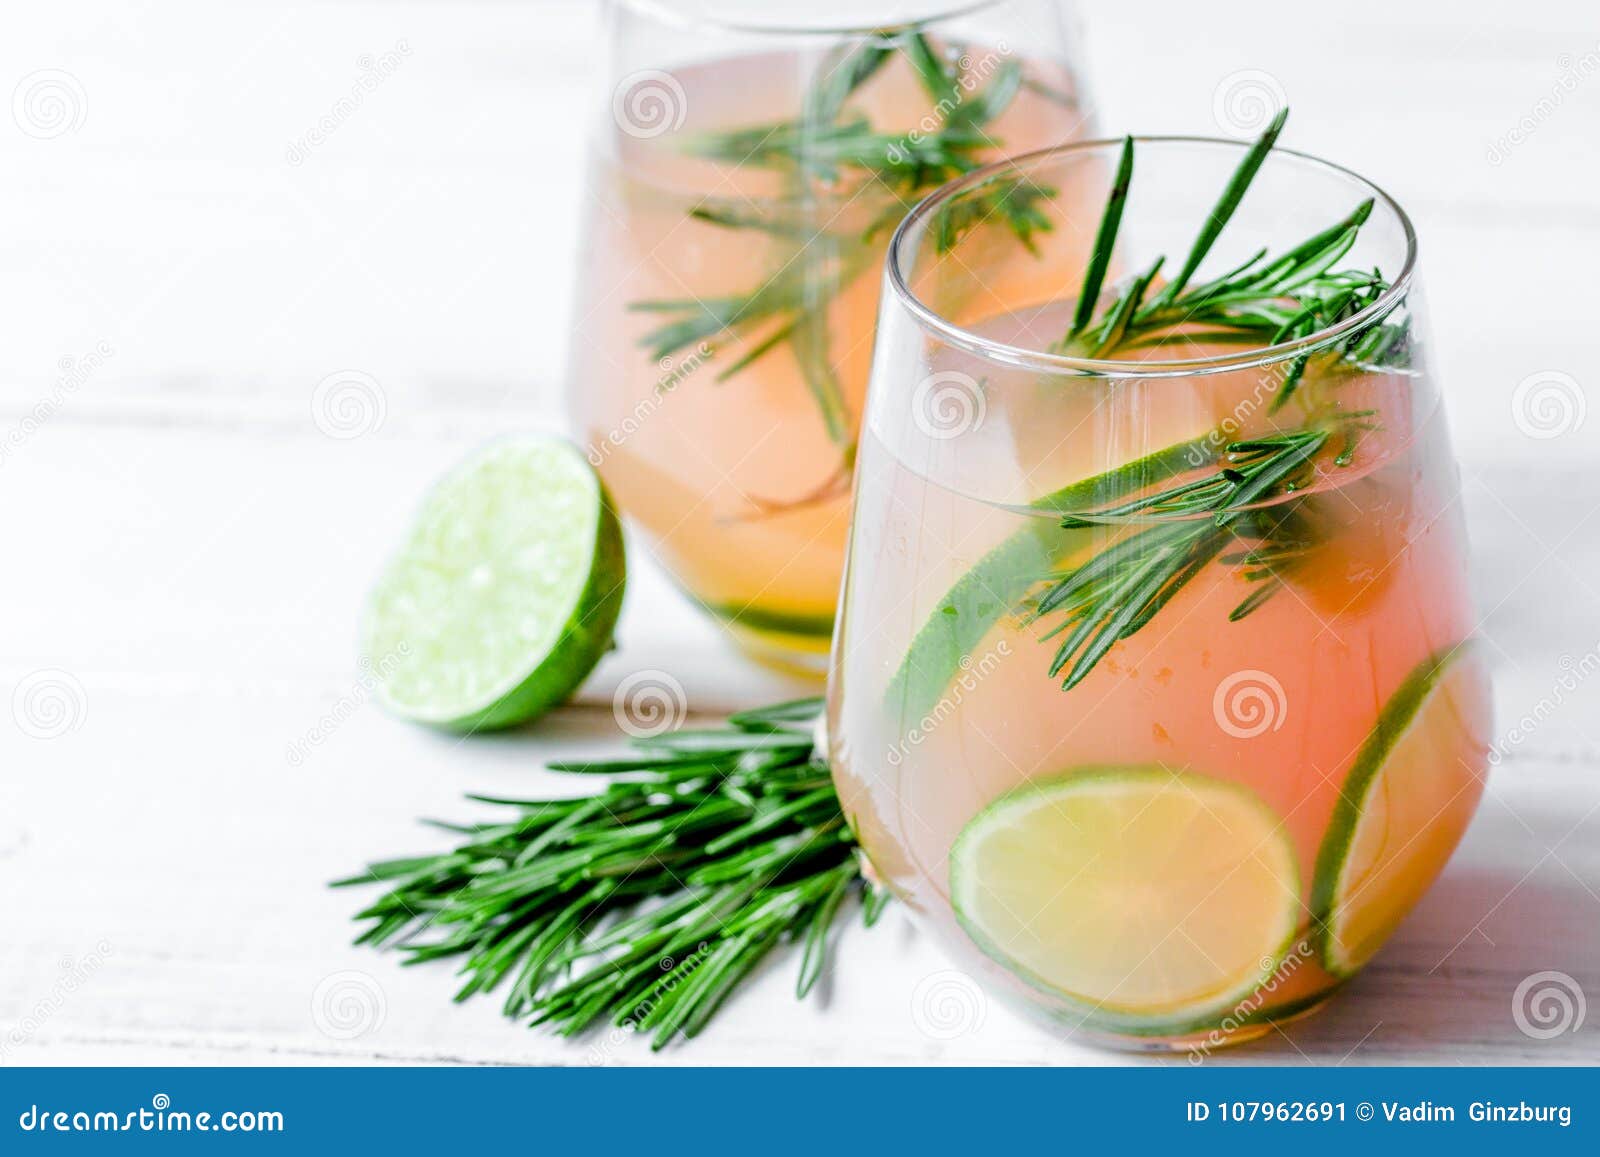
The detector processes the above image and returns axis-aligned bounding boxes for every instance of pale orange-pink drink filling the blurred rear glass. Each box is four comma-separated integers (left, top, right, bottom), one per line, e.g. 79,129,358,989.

570,46,1085,663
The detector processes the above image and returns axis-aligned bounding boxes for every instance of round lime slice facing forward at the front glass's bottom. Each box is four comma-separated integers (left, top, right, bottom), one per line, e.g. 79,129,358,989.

950,767,1301,1035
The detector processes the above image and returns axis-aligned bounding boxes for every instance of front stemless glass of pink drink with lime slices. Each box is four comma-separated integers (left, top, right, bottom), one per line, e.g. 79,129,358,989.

829,138,1490,1050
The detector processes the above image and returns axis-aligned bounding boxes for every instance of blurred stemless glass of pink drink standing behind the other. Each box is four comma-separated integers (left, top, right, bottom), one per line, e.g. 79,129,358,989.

568,0,1086,672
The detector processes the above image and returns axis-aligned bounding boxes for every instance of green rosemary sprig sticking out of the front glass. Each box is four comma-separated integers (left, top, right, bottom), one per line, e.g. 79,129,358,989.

1027,109,1408,688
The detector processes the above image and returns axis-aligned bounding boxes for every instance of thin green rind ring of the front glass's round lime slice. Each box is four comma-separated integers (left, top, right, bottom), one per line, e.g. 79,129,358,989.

950,765,1299,1039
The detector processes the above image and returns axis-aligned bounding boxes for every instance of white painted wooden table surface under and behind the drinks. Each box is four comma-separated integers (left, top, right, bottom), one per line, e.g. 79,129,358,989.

0,0,1600,1064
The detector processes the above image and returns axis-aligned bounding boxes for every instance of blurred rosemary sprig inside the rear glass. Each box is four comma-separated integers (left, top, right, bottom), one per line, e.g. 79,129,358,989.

630,27,1054,473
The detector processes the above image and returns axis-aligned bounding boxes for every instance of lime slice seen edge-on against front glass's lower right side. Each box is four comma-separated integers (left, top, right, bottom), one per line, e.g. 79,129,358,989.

1312,643,1488,976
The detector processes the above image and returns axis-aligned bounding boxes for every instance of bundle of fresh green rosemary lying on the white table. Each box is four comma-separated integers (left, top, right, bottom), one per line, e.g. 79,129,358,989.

333,699,886,1048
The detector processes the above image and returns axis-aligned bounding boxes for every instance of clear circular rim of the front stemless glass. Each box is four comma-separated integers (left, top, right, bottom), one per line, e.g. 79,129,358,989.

885,136,1418,378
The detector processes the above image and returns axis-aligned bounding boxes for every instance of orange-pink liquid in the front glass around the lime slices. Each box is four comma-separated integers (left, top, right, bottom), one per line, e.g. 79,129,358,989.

829,307,1490,1031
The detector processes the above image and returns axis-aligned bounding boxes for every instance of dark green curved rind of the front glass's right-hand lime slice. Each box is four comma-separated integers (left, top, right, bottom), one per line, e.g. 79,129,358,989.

1310,639,1474,976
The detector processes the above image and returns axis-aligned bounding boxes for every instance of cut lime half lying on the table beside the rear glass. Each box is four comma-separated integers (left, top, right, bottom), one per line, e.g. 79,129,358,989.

363,437,626,731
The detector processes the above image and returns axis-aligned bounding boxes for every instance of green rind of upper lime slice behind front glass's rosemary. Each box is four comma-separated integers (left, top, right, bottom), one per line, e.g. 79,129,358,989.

885,434,1222,719
